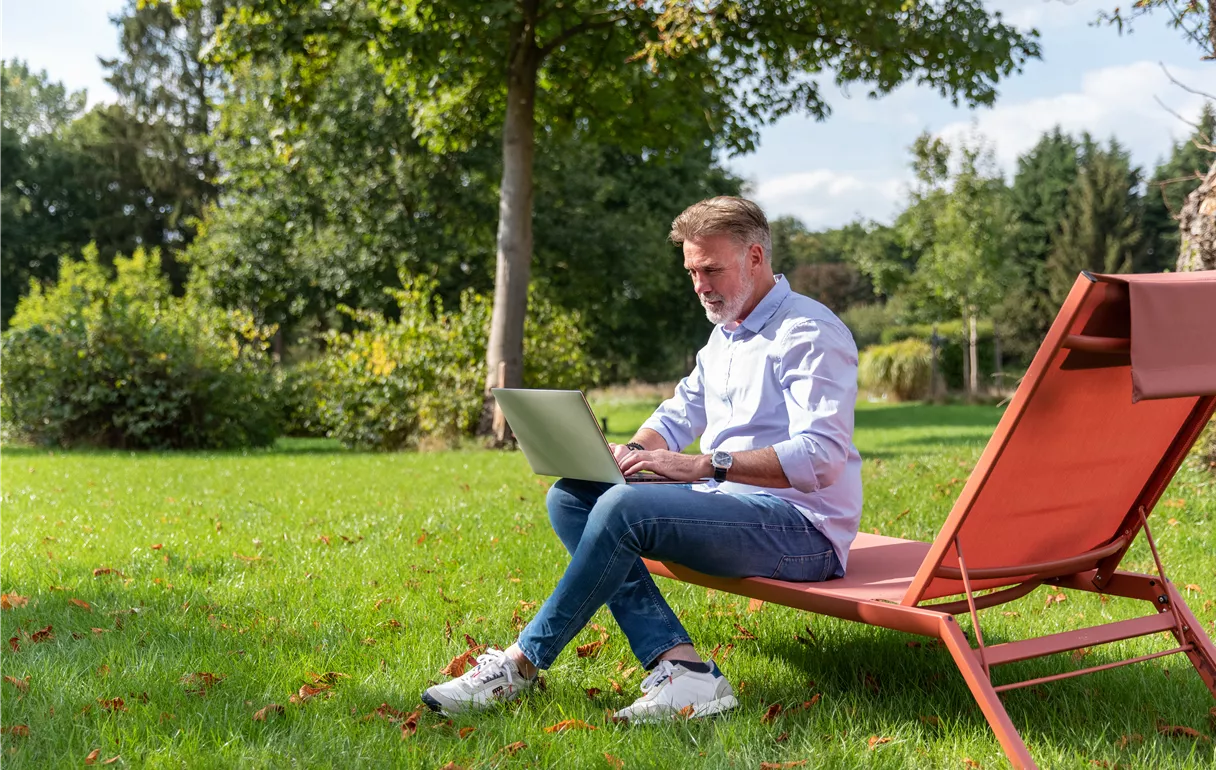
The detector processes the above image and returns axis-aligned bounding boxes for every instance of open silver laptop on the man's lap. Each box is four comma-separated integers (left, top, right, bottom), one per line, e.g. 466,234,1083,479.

491,388,689,484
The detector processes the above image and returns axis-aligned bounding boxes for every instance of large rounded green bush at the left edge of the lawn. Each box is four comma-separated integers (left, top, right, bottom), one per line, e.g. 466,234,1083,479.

0,247,278,449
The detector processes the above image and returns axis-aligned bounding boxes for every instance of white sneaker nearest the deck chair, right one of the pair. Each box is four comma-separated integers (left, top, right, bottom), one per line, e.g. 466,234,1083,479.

614,661,739,723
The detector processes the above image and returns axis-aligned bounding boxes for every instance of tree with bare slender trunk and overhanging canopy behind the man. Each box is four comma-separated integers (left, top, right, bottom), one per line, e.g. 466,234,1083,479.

196,0,1038,437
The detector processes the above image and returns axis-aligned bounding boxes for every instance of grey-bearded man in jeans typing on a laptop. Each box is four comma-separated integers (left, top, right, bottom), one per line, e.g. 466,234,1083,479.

422,197,861,721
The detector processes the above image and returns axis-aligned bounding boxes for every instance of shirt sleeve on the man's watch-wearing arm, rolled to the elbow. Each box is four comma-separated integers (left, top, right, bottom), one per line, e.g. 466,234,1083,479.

773,321,857,493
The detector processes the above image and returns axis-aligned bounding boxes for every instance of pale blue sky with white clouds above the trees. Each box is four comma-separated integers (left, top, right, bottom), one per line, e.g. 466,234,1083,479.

0,0,1216,229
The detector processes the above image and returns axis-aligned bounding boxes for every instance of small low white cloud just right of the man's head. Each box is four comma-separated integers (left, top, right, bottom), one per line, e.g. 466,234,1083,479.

753,169,906,229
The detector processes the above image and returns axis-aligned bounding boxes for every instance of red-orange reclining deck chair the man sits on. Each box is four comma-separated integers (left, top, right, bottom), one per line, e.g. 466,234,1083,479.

647,272,1216,768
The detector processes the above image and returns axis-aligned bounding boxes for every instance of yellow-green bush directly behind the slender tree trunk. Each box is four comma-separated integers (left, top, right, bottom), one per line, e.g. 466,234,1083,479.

320,276,596,450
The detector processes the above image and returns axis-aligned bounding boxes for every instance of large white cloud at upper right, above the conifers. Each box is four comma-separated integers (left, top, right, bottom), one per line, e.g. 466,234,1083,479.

938,61,1211,172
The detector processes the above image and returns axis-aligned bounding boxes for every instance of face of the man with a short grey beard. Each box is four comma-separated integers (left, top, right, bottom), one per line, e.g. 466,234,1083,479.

683,235,758,324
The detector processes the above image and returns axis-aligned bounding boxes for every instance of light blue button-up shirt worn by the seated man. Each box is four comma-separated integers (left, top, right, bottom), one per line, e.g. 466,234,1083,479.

642,275,861,574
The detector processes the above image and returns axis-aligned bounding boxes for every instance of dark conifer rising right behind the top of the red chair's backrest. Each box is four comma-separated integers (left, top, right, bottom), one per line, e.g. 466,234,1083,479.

1047,135,1144,301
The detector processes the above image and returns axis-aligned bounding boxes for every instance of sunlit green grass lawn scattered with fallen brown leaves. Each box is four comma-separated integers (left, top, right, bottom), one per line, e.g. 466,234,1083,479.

0,403,1216,769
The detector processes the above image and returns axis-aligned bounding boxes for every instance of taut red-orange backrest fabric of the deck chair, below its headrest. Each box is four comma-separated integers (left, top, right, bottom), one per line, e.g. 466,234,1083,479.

903,274,1216,605
